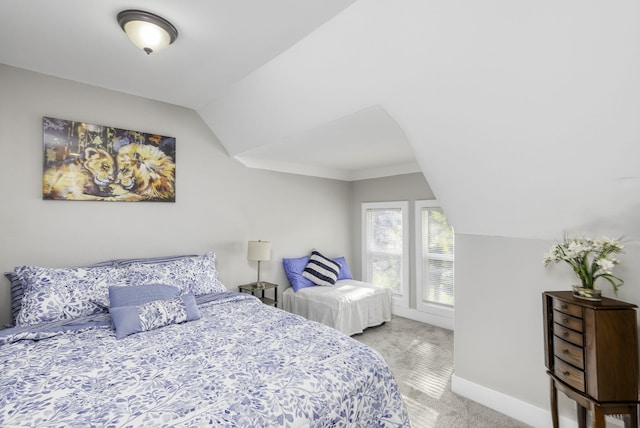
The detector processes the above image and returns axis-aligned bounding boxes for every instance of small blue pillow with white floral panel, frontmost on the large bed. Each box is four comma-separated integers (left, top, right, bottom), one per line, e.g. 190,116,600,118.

110,294,202,339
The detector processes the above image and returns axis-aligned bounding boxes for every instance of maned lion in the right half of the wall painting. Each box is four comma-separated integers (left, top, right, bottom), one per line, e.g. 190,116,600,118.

114,143,176,201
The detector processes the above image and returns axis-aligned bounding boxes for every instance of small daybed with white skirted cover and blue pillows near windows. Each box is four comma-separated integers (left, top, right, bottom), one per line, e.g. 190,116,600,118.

282,252,392,336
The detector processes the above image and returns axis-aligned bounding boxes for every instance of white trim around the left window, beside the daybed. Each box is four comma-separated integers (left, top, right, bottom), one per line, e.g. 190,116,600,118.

361,201,411,308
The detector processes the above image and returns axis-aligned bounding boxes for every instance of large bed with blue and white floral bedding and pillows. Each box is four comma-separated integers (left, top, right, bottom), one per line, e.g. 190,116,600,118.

0,253,409,427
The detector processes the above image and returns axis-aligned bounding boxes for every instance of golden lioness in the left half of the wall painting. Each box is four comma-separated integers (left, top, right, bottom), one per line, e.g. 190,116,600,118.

42,147,115,200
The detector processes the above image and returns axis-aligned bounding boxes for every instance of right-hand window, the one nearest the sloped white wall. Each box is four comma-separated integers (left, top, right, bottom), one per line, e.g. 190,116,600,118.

416,201,454,315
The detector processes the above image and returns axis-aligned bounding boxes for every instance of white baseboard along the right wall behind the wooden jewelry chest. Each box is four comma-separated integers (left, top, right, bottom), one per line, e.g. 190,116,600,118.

451,374,624,428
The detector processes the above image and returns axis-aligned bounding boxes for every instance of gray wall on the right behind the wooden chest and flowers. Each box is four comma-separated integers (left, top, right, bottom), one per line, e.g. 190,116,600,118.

454,231,640,426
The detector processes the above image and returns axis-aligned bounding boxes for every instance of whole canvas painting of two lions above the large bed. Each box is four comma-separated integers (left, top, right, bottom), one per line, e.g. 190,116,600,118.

42,117,176,202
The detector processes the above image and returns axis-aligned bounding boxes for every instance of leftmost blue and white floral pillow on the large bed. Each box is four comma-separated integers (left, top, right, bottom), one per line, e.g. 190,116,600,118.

14,266,124,327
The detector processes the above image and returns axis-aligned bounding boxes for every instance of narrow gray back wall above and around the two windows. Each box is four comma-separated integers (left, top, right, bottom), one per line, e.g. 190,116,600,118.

349,173,435,308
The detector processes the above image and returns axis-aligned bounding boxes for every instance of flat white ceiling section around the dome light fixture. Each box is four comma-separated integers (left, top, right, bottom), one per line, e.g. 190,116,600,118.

0,0,353,110
